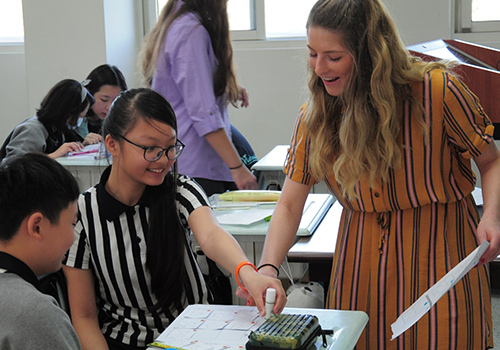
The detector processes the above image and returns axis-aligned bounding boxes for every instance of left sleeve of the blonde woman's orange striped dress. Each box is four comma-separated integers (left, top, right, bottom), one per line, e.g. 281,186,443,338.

283,104,316,185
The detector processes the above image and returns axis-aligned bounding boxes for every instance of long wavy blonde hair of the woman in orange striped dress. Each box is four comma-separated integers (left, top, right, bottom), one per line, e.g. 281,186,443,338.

307,0,448,199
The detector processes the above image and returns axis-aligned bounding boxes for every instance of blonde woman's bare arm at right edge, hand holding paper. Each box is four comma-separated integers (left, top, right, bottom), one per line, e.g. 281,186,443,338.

474,142,500,264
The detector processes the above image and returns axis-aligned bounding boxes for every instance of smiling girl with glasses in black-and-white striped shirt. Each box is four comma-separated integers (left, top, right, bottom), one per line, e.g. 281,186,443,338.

63,89,286,350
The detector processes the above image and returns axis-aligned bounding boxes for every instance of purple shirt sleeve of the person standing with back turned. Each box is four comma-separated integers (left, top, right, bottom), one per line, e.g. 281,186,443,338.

166,24,225,136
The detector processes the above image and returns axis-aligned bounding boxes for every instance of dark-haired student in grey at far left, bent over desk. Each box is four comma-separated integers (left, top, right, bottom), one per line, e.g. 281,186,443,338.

0,79,94,163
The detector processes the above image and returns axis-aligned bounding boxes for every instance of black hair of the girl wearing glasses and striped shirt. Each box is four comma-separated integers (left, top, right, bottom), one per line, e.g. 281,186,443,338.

103,88,186,310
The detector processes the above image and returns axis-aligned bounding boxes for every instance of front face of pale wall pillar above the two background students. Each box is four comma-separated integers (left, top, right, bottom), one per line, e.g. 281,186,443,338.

23,0,106,115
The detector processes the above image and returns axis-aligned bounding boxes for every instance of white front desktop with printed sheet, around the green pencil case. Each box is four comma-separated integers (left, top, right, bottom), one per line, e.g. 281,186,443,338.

148,305,368,350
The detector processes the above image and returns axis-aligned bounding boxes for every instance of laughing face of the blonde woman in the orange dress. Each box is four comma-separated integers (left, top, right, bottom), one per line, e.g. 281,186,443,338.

307,26,353,96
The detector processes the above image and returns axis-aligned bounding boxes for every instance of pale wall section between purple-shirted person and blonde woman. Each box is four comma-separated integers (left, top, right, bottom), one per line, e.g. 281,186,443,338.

230,40,308,158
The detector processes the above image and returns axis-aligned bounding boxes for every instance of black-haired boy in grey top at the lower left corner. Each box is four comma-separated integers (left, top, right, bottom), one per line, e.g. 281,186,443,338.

0,153,80,350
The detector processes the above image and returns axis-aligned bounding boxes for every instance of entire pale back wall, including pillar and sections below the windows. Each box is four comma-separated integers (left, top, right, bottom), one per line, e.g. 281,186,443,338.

0,0,500,157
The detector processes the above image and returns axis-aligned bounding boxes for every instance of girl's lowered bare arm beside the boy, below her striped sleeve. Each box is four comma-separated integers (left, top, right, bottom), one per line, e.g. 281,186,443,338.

63,266,108,350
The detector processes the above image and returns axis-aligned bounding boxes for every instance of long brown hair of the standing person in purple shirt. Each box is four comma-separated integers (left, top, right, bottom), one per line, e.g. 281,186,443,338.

139,0,238,104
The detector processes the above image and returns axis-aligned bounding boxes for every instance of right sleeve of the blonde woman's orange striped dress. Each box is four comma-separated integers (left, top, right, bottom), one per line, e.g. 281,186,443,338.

443,74,494,159
